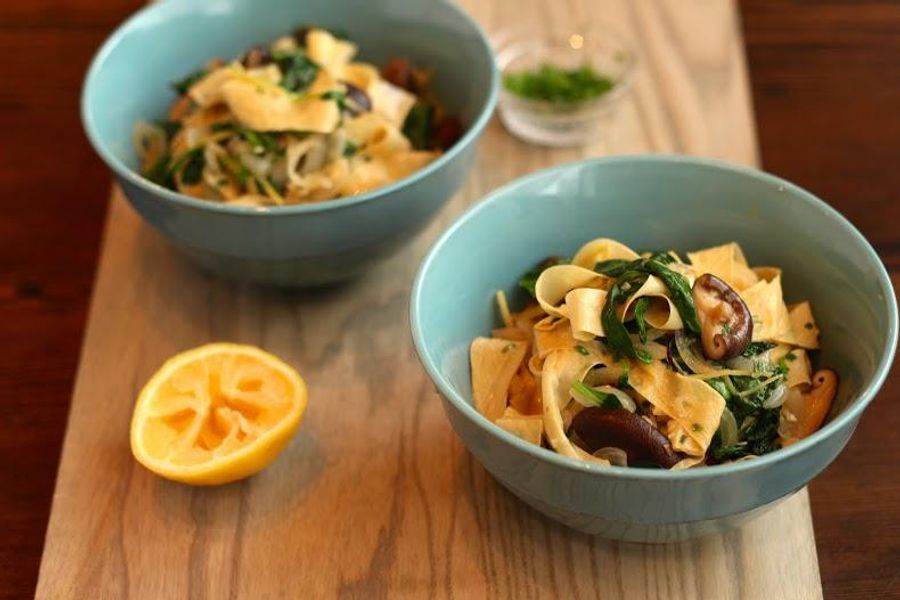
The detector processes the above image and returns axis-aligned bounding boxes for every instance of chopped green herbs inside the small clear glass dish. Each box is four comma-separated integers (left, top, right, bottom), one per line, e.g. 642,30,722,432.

503,65,614,104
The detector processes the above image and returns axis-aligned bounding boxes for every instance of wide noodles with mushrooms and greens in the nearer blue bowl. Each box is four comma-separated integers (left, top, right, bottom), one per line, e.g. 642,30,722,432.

470,239,837,469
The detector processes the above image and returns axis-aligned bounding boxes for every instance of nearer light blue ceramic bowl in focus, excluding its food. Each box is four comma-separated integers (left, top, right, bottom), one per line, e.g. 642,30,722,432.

411,156,897,542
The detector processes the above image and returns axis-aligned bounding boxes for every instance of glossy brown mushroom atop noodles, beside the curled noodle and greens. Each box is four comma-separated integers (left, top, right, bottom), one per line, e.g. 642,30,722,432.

691,273,753,360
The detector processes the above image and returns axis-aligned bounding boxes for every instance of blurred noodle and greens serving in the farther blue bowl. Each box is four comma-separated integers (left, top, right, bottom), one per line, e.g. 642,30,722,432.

134,28,461,206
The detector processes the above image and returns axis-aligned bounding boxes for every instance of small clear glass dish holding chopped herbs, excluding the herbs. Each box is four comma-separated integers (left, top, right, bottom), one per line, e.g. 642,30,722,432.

497,27,637,147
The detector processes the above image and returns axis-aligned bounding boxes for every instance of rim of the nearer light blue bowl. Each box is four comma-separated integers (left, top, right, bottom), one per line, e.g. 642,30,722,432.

409,154,897,481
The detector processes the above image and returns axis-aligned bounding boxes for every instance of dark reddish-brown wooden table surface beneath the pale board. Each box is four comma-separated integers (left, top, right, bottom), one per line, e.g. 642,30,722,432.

0,0,900,598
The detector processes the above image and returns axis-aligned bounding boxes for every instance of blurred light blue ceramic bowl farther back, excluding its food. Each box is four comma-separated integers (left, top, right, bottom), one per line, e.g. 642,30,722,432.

82,0,499,286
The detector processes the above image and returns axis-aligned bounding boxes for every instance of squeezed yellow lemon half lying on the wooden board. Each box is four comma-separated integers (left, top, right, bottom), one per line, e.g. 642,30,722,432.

131,343,307,485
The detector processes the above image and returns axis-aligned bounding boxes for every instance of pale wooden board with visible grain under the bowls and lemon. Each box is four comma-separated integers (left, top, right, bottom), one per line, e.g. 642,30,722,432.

37,0,822,600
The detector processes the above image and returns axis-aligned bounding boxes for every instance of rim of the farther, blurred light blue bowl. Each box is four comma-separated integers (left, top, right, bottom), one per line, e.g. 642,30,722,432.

80,0,500,217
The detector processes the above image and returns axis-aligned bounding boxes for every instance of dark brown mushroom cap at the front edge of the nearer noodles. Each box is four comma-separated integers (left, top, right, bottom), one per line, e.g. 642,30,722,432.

572,406,682,469
